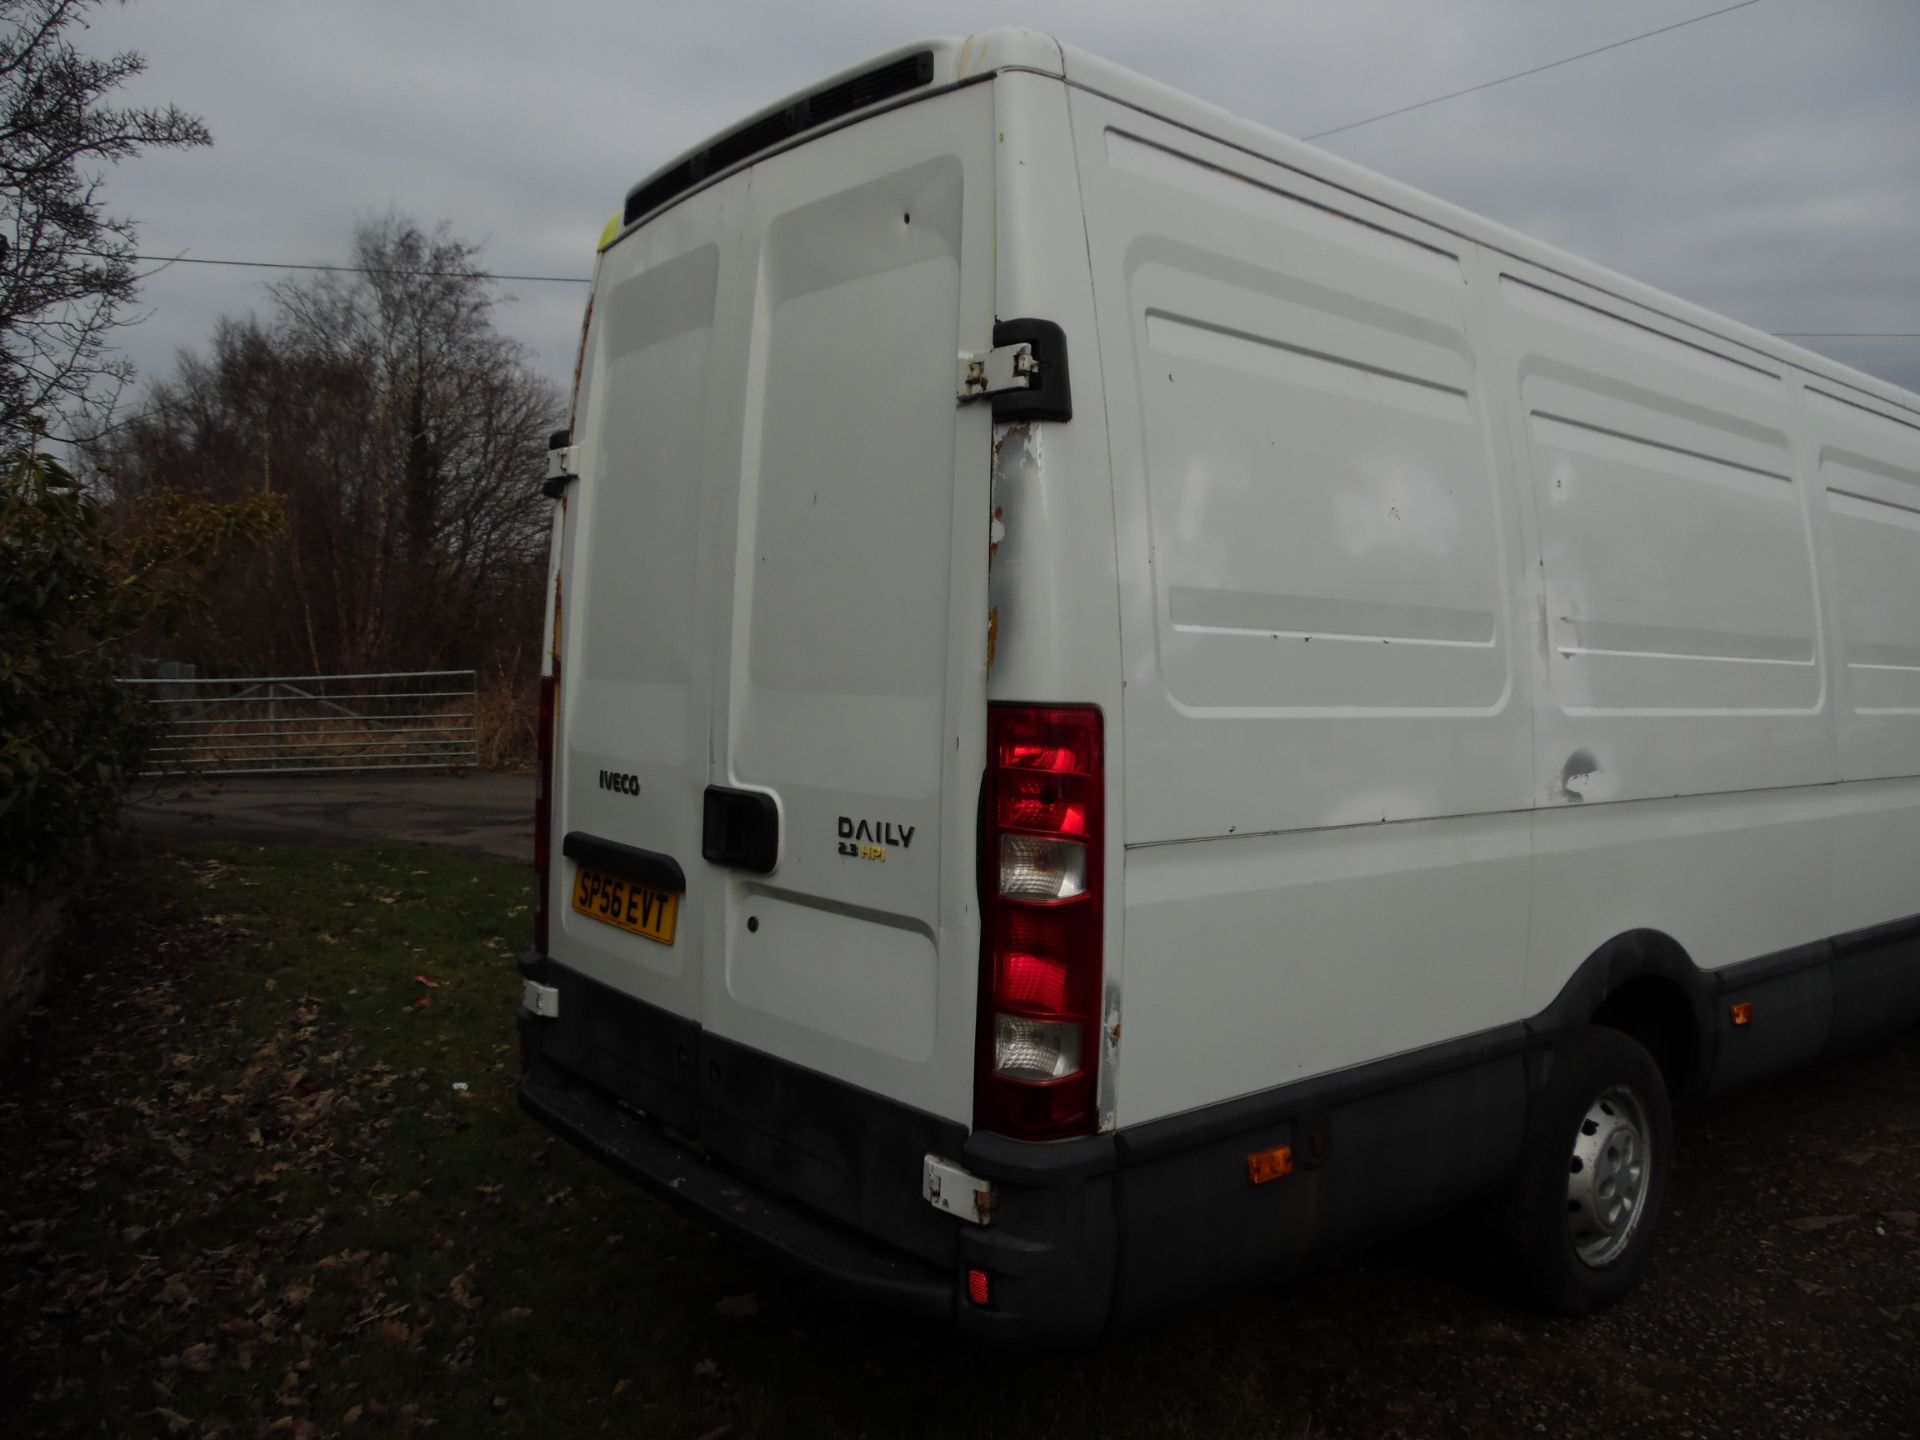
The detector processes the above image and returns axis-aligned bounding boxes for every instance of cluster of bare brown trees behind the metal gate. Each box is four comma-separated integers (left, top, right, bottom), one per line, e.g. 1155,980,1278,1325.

108,215,563,687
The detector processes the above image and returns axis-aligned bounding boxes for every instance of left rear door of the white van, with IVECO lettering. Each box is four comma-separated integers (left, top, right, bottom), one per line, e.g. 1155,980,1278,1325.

553,214,737,1018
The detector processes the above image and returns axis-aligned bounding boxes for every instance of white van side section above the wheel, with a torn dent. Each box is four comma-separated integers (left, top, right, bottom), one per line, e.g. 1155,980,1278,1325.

1486,268,1836,1013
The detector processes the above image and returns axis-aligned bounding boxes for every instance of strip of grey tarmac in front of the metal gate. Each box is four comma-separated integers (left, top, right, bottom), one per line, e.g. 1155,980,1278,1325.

129,772,534,864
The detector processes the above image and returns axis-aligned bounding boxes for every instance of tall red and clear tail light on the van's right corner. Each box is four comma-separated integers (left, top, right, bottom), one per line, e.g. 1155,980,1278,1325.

973,705,1106,1140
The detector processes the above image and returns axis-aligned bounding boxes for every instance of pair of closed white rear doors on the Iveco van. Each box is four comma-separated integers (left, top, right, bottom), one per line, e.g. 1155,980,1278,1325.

553,84,995,1121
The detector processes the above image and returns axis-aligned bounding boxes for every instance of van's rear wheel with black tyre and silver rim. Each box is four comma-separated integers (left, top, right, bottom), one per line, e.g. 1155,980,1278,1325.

1507,1027,1672,1315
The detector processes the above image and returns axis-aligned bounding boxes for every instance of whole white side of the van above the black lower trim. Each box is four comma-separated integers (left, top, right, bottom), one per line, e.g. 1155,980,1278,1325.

1071,81,1920,1125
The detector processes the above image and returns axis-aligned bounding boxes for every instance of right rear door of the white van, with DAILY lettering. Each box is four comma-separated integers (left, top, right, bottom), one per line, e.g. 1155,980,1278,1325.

705,86,993,1117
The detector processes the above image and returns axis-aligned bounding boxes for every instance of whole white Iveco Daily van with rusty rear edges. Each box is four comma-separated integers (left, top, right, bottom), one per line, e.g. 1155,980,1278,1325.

520,31,1920,1338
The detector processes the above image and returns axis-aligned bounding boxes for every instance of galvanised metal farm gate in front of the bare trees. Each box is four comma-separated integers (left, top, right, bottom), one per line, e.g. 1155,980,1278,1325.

121,670,478,776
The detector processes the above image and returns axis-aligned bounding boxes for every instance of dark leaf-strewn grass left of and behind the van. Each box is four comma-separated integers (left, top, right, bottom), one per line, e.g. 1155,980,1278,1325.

0,845,1328,1440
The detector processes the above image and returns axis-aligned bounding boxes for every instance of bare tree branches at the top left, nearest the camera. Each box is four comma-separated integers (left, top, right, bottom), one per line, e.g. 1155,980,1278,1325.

0,0,211,434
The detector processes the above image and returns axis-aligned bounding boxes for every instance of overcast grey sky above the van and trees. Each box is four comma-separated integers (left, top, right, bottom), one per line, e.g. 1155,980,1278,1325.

84,0,1920,407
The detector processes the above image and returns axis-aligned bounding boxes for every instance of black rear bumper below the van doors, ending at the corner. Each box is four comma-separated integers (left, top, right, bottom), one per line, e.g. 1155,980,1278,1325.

520,956,1116,1344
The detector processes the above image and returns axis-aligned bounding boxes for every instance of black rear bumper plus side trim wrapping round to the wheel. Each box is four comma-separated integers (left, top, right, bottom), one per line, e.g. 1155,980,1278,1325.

520,956,1530,1346
